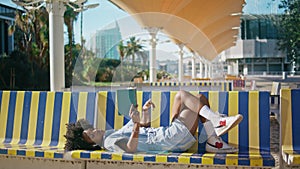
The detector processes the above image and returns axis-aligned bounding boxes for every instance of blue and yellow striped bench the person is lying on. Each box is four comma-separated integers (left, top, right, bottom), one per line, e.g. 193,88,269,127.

69,91,275,168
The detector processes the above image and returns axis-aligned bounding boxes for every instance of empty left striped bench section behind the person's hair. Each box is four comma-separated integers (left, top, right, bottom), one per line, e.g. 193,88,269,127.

0,91,97,159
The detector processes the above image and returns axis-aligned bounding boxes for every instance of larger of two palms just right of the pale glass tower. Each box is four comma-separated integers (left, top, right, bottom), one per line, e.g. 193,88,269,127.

126,37,144,66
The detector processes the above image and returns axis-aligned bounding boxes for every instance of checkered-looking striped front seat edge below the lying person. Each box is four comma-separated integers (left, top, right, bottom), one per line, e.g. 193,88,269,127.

71,150,274,167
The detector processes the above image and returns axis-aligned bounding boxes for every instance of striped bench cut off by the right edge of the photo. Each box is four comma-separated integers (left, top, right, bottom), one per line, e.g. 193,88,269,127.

280,89,300,166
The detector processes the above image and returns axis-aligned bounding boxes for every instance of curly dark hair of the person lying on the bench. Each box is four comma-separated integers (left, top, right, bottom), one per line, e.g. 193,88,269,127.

64,119,101,151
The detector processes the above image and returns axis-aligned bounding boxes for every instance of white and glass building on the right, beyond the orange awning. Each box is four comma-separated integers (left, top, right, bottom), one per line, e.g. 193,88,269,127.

222,14,289,75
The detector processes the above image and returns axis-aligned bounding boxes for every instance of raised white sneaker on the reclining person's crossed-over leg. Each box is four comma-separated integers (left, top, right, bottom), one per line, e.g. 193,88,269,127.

214,114,243,136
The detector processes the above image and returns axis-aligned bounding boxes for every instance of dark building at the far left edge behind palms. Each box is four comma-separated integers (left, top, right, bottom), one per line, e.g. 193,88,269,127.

0,2,17,57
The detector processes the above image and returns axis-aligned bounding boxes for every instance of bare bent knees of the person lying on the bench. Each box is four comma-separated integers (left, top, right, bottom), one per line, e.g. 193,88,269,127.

172,91,209,134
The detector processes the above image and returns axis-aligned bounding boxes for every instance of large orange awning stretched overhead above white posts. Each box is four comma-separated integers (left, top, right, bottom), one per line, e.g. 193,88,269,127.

110,0,245,60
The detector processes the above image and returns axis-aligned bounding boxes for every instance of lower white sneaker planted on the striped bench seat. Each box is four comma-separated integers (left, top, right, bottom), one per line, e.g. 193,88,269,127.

205,136,239,153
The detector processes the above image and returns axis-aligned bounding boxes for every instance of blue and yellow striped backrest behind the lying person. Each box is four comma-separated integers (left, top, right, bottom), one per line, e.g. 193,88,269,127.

94,91,270,161
